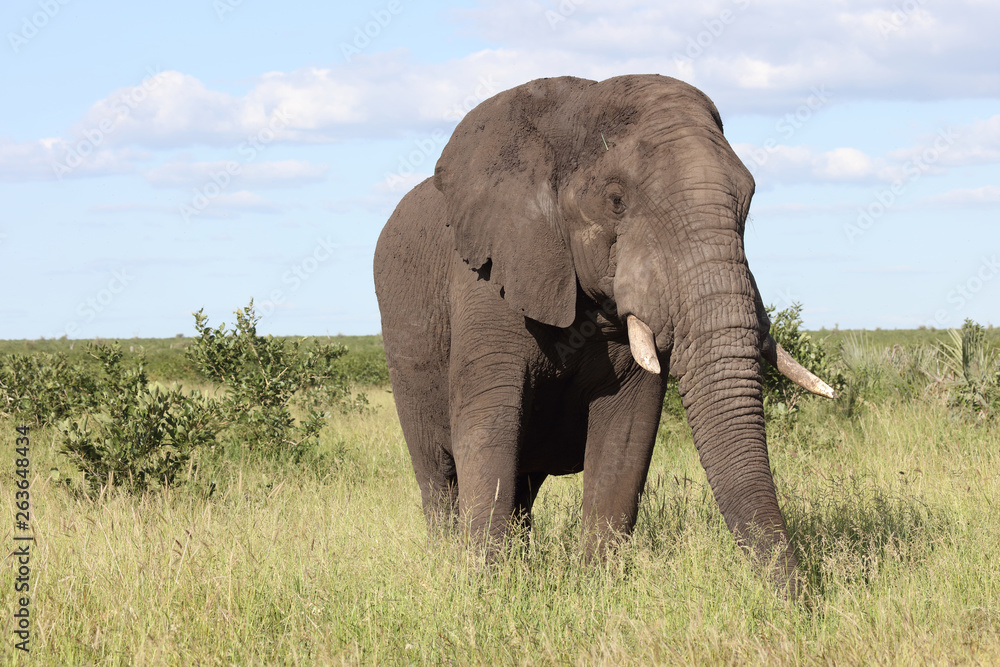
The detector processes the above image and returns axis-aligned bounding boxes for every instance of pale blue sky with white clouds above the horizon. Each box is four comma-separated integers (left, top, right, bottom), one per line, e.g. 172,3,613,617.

0,0,1000,338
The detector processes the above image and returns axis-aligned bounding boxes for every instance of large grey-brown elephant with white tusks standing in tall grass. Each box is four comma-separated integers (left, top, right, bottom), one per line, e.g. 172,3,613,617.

374,75,834,593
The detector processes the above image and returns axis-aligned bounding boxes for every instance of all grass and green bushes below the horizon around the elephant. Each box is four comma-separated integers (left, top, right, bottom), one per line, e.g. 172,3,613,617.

0,307,1000,665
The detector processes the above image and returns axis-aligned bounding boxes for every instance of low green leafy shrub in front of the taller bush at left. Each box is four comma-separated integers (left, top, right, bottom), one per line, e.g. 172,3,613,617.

59,342,217,491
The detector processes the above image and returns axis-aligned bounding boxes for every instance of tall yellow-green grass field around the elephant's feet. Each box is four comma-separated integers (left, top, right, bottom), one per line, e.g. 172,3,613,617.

0,332,1000,665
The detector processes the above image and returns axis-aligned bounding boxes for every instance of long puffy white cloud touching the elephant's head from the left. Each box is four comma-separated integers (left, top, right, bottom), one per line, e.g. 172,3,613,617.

63,56,522,149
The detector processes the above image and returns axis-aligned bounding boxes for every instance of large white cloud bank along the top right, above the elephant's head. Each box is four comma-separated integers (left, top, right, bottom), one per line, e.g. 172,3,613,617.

461,0,1000,112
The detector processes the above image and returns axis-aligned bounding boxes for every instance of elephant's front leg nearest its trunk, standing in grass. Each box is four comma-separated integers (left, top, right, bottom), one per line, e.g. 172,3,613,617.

583,366,666,560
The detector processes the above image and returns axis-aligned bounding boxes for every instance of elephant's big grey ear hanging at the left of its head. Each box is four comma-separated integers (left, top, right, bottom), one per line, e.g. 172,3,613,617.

434,77,592,327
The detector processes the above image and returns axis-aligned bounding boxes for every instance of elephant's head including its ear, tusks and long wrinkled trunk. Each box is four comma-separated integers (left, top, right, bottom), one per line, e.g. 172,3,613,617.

434,75,832,592
